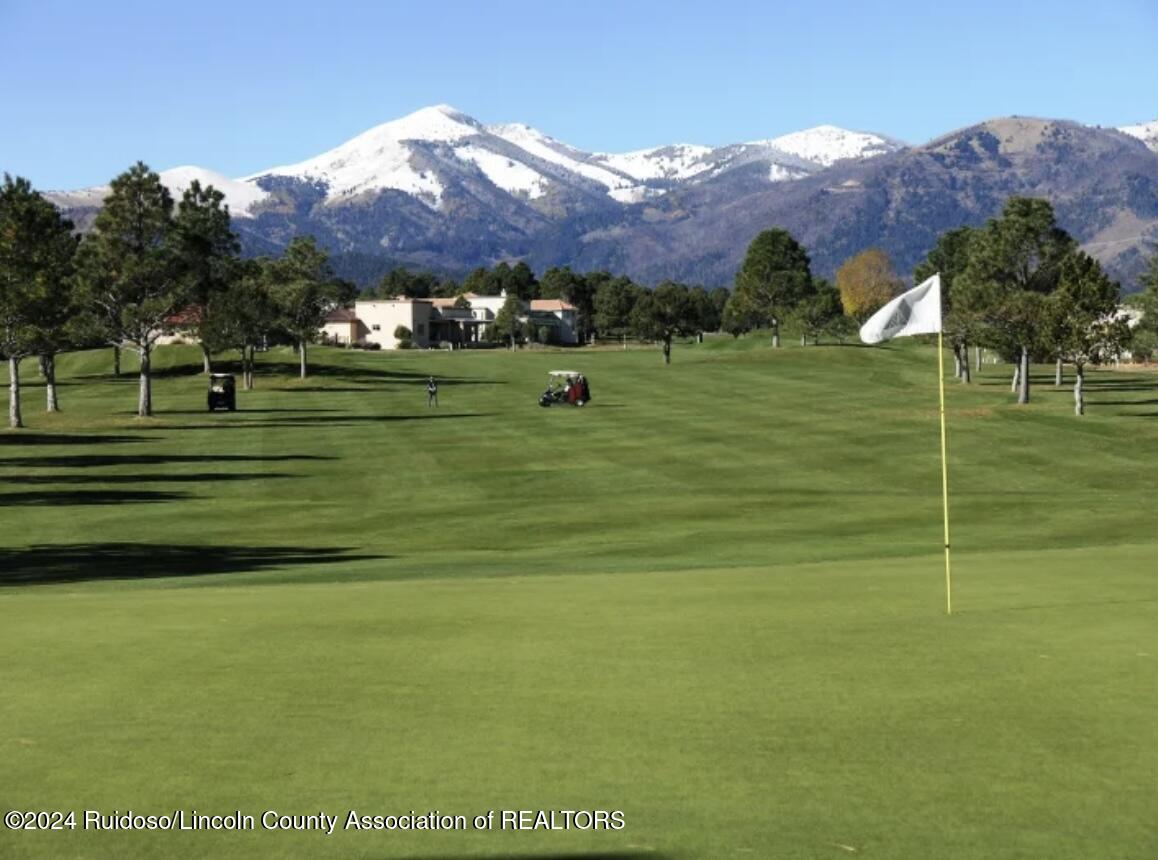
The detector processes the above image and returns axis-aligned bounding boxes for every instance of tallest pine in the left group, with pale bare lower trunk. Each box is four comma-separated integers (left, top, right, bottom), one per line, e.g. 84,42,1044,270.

76,162,189,418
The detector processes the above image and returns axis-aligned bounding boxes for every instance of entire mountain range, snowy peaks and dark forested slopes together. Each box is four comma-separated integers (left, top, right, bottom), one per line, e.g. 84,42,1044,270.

40,105,1158,287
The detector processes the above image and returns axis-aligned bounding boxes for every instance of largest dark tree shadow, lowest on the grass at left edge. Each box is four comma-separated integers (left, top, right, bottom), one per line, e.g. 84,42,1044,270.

0,543,389,587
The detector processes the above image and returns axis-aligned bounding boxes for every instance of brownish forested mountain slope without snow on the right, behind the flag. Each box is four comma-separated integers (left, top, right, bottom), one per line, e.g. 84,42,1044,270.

576,118,1158,285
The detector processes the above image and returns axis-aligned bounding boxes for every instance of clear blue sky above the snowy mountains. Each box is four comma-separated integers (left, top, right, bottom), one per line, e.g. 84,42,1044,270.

0,0,1158,189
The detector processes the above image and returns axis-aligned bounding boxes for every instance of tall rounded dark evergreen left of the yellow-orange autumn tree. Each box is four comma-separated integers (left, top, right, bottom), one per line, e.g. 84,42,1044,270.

733,228,812,346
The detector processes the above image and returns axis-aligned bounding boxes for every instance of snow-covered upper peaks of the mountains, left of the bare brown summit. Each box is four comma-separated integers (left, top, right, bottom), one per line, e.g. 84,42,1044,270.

54,104,903,218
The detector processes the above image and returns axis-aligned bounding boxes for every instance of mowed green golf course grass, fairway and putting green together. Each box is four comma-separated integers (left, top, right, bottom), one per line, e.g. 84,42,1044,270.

0,338,1158,860
